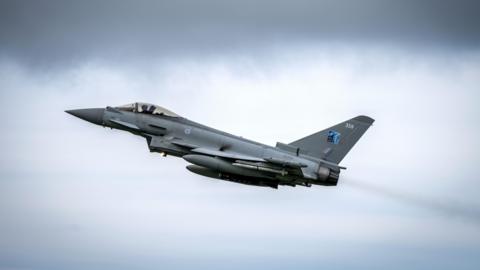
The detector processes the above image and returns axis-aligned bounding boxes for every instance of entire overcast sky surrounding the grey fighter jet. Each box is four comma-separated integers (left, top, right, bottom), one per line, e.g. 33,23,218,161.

0,0,480,270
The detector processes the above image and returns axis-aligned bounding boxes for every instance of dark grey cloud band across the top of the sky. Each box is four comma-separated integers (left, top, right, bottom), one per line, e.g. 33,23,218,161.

0,0,480,64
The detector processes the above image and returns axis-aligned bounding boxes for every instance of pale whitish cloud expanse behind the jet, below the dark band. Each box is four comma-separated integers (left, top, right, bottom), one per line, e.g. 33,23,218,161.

0,47,480,269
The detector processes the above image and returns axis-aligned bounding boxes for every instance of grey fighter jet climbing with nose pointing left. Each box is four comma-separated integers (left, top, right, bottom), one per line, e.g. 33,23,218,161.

66,102,374,189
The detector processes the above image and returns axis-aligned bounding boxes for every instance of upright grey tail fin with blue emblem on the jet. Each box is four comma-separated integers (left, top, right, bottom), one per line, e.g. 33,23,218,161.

290,115,375,164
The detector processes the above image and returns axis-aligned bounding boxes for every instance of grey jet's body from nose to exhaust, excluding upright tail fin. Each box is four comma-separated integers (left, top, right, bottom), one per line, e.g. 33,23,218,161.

67,104,350,188
